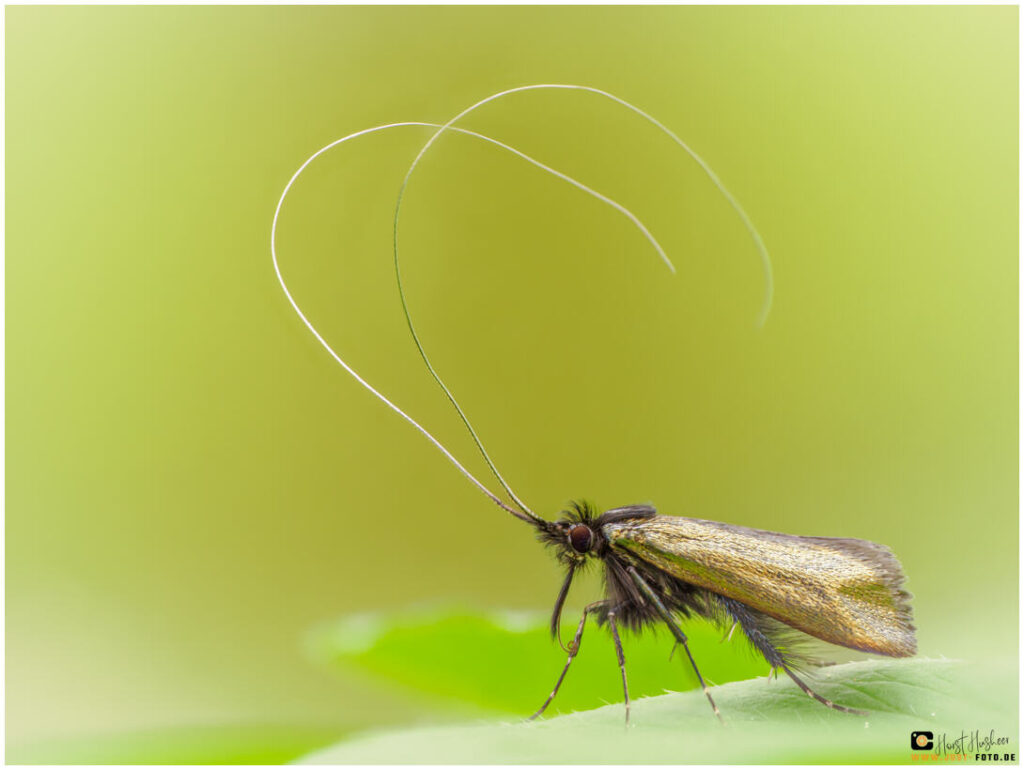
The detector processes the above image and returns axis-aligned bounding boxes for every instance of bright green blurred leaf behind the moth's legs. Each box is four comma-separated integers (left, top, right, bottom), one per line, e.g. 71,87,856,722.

309,609,768,716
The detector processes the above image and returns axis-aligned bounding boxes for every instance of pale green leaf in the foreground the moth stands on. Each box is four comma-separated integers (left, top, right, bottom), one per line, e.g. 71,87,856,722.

302,659,1019,764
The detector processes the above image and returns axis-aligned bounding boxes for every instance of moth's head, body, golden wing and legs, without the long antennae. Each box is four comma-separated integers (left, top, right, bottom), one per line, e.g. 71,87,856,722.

528,503,916,721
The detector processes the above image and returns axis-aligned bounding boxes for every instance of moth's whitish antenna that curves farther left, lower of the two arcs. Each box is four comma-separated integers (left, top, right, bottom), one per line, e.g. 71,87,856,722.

270,121,664,523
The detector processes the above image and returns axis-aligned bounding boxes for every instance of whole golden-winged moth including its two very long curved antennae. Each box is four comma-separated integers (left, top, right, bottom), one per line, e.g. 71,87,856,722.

270,84,916,722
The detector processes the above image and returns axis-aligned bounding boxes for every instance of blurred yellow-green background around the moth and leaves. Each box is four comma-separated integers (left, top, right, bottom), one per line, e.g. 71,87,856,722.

5,7,1018,761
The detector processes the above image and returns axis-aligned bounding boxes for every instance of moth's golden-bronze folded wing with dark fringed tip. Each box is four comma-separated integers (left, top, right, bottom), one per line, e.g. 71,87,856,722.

601,516,916,657
